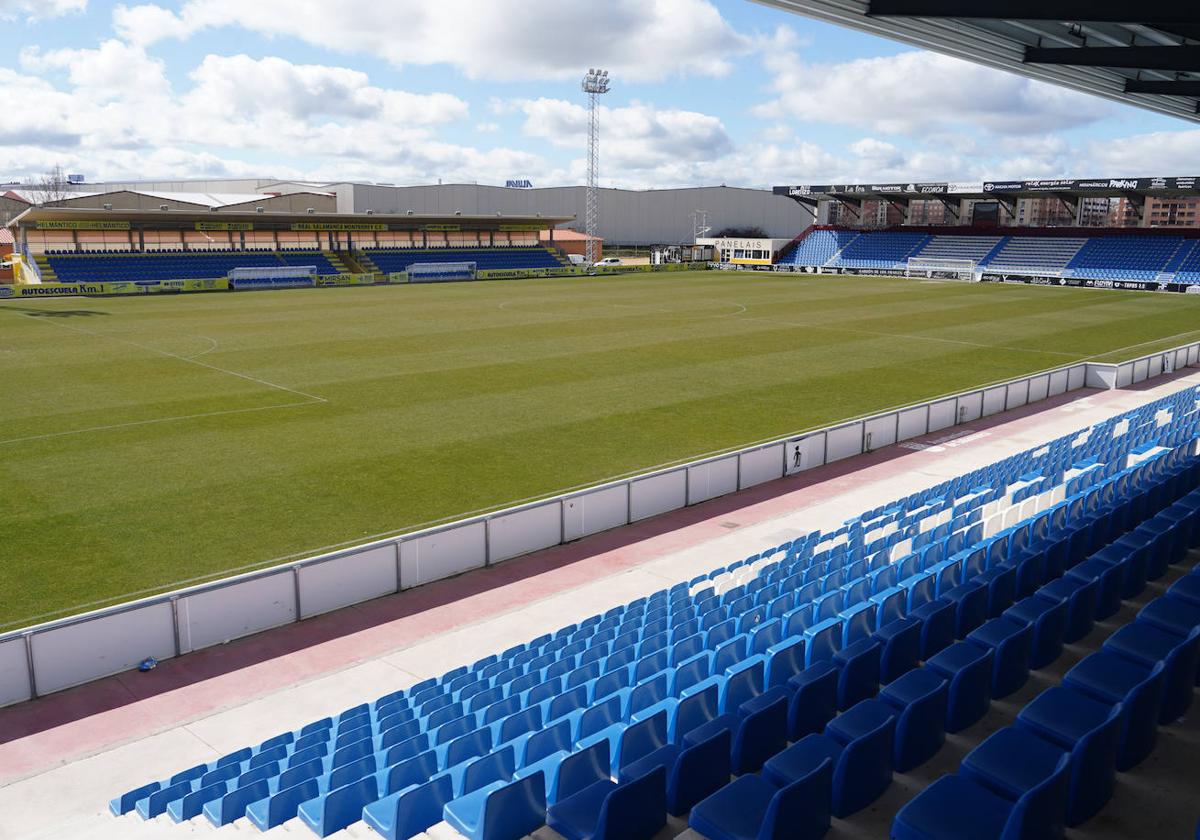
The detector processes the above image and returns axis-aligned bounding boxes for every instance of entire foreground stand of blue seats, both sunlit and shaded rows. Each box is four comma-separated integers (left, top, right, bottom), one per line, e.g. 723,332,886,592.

109,388,1200,840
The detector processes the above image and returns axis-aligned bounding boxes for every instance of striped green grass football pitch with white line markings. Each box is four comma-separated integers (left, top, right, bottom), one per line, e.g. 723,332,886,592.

0,272,1200,629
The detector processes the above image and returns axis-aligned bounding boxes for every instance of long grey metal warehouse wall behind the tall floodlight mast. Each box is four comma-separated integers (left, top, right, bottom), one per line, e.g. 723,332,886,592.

350,184,812,245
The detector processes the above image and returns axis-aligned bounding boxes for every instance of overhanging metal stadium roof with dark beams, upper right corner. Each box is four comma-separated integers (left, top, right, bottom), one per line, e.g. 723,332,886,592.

757,0,1200,122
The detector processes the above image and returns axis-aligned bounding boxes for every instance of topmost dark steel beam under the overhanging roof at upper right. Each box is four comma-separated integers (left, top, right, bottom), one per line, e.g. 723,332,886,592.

866,0,1200,26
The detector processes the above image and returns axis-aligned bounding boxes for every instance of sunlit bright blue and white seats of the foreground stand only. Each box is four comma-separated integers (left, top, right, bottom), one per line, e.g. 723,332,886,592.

112,390,1196,838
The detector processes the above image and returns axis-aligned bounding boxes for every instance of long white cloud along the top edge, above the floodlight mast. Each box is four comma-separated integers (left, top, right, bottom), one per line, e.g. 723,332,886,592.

113,0,752,83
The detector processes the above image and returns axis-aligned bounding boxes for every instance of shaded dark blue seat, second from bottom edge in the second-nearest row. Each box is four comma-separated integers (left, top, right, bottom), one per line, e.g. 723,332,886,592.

762,700,896,817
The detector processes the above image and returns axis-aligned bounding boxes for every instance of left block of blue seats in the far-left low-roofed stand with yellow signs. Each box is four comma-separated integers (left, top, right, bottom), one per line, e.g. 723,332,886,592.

47,251,337,283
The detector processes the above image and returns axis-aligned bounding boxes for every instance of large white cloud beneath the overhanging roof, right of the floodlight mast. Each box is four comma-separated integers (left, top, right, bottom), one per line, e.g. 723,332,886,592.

755,49,1111,136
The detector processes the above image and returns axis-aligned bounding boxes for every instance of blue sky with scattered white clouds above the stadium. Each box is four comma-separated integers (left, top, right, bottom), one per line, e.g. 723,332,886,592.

0,0,1200,188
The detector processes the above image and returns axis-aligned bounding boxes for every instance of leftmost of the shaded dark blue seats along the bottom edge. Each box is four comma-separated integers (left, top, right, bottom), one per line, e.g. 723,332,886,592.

544,766,667,840
